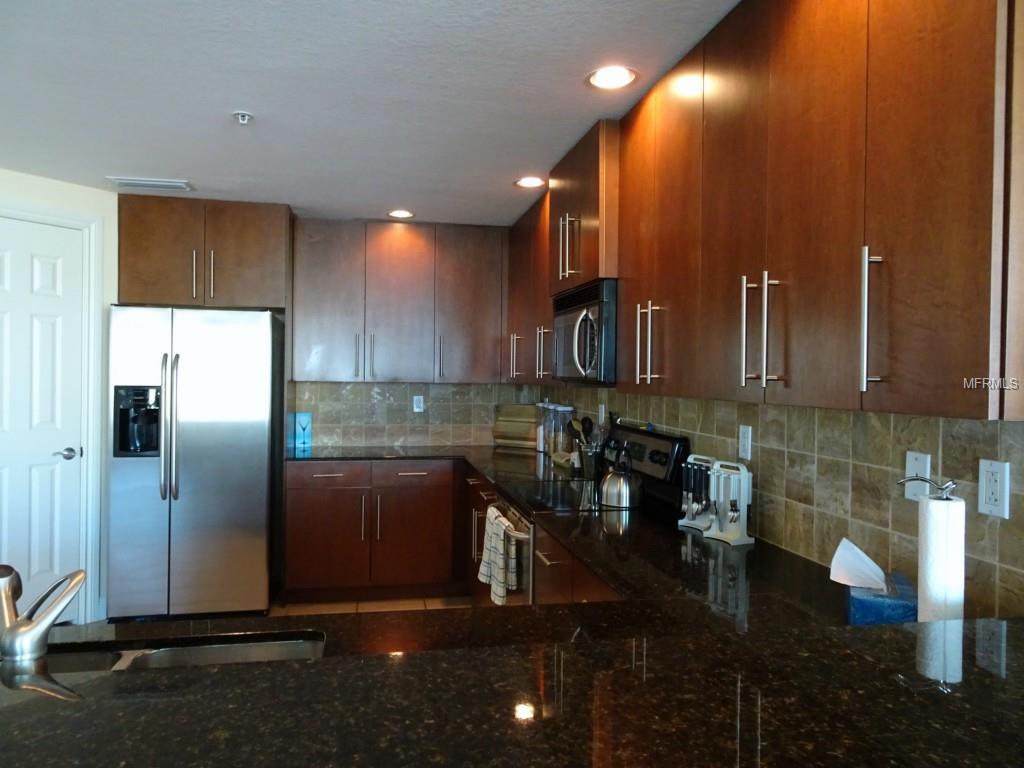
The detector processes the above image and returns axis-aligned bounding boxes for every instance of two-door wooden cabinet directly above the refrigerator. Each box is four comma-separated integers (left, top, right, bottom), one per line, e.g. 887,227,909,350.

118,195,292,307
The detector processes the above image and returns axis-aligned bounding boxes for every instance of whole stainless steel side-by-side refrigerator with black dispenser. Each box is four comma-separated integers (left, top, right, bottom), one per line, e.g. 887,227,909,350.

106,306,280,617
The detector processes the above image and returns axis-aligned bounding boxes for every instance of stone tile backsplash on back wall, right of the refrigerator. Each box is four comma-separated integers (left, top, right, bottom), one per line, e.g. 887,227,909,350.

287,382,538,446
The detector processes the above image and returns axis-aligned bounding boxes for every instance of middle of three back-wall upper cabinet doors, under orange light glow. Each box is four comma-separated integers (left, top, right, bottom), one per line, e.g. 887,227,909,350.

366,222,436,381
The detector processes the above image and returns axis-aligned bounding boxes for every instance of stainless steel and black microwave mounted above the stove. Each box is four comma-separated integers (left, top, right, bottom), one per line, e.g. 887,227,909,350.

554,280,616,385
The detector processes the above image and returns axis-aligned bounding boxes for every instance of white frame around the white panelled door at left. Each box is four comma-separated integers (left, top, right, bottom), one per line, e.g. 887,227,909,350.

0,206,106,622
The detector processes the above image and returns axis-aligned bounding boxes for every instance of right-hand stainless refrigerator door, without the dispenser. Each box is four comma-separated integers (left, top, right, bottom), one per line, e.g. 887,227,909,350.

170,309,272,613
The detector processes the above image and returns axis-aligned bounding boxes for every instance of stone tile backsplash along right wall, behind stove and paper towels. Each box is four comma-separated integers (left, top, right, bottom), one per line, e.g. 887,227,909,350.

541,386,1024,615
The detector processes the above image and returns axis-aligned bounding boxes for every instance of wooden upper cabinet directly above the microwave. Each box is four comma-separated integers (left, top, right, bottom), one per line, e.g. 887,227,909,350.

549,120,618,295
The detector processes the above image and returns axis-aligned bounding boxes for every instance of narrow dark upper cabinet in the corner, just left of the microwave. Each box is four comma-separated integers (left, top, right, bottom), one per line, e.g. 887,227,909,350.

502,196,550,384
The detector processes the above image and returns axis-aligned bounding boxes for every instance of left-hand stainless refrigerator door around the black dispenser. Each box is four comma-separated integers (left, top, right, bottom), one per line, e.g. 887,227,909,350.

106,306,171,616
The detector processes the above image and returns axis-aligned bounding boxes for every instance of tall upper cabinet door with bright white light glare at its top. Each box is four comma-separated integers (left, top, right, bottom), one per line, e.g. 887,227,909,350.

655,44,705,394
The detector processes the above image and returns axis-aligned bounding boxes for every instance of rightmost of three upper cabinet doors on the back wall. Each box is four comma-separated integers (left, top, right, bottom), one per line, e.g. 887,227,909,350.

434,224,504,384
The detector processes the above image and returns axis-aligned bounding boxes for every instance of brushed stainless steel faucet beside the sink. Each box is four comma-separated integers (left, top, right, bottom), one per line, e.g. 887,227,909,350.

0,565,85,662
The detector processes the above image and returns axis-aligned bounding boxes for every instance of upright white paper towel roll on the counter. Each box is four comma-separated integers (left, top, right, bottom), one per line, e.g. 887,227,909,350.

918,496,966,622
